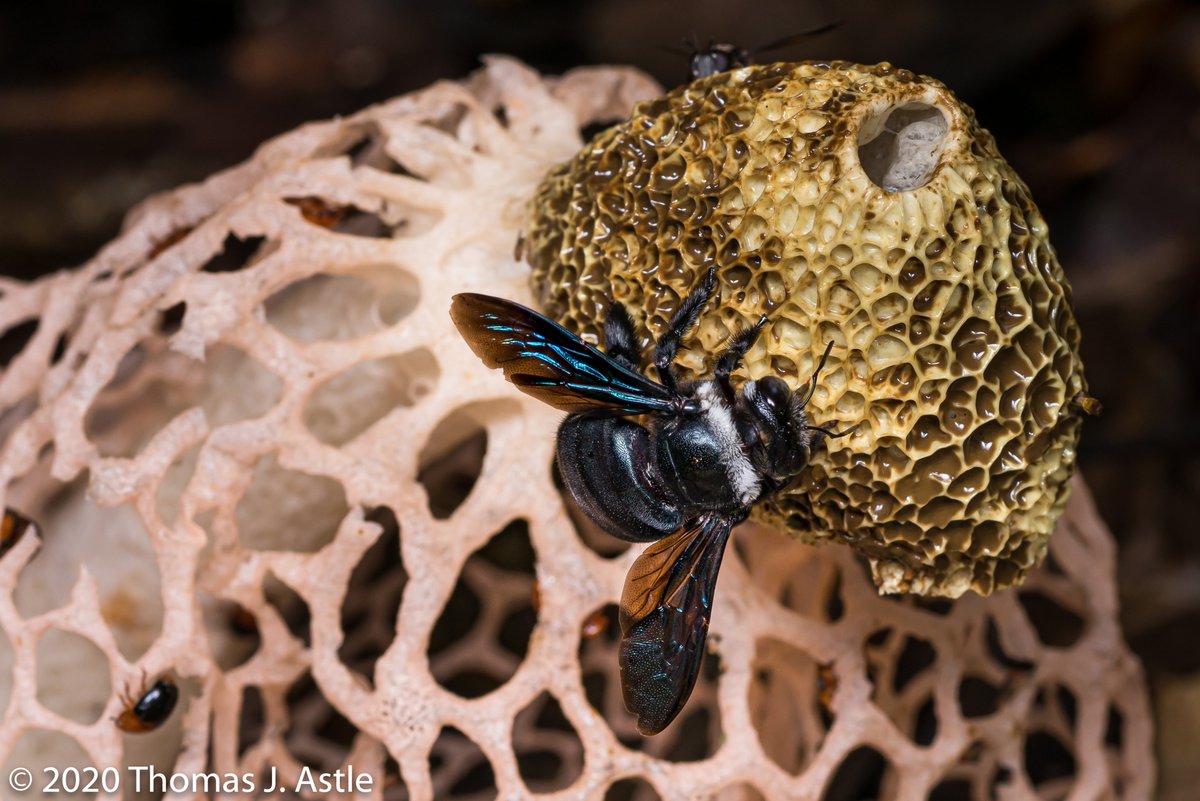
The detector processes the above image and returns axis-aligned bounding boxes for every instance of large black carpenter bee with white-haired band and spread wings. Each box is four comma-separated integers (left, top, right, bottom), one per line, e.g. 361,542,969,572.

450,270,841,735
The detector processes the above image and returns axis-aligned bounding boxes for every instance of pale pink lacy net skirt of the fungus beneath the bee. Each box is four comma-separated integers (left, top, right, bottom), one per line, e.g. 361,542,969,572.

0,59,1152,801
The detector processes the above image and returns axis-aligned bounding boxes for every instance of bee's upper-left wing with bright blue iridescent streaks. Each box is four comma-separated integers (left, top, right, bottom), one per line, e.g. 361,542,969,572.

450,293,677,415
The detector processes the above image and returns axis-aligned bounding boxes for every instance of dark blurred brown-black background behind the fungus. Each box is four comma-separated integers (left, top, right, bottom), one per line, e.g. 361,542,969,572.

0,0,1200,799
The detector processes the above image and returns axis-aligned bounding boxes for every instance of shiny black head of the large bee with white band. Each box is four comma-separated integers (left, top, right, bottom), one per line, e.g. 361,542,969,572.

737,375,821,483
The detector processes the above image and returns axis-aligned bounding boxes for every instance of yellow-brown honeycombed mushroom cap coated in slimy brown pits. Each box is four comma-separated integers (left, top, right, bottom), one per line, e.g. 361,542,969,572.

527,62,1086,597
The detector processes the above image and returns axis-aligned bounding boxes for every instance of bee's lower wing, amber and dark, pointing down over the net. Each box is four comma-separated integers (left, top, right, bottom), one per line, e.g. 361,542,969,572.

620,513,733,735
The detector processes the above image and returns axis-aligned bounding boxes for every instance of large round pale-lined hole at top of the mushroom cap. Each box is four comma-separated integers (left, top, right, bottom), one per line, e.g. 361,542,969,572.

858,102,949,192
